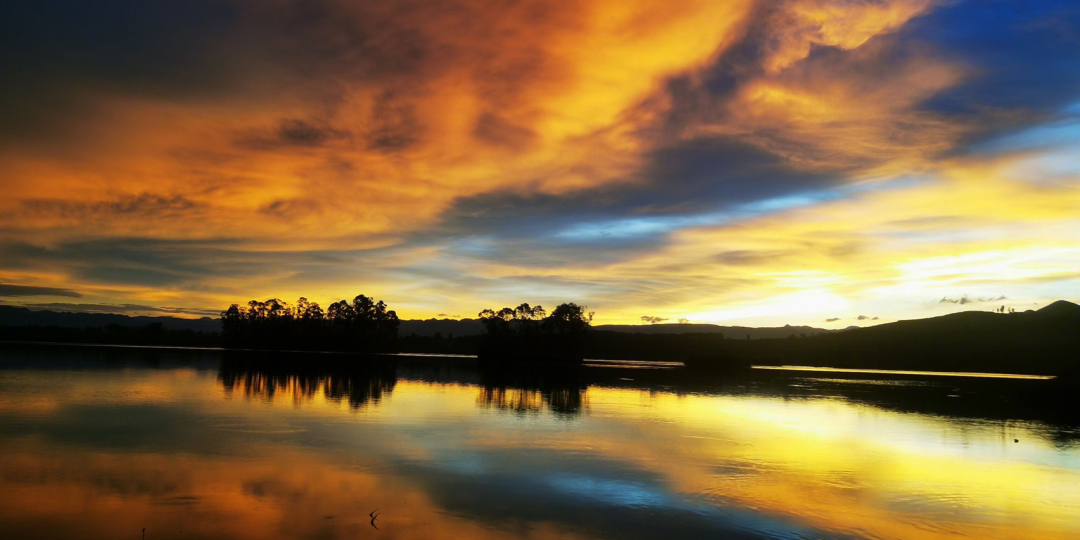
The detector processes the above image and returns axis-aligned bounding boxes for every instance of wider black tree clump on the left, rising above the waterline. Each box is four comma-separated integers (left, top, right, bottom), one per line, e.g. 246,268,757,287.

221,295,400,352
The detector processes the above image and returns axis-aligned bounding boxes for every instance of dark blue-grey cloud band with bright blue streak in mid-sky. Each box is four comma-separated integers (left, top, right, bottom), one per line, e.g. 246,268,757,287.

411,138,841,266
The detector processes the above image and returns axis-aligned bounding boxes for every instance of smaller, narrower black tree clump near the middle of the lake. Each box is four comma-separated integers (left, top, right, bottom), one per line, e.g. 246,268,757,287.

478,302,593,362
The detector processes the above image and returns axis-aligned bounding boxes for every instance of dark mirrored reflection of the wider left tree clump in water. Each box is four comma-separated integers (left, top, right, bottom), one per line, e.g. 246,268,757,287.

217,354,397,410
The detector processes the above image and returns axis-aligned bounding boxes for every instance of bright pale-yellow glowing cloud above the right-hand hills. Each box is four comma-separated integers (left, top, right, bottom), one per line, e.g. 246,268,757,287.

557,156,1080,323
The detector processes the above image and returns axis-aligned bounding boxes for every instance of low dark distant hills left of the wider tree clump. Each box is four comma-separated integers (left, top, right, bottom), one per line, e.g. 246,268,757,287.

0,306,221,334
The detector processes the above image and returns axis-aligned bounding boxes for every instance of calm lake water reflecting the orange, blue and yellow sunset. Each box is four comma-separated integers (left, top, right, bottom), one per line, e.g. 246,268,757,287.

0,346,1080,540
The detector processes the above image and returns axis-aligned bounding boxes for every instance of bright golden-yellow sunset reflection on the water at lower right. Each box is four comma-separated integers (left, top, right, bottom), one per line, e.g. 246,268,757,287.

592,391,1080,539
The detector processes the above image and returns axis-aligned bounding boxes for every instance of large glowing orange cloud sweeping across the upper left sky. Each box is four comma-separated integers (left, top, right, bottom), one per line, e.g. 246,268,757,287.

2,1,748,247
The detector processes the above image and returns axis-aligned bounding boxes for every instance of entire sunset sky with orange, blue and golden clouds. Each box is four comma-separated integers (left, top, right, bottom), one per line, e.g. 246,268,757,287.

0,0,1080,328
